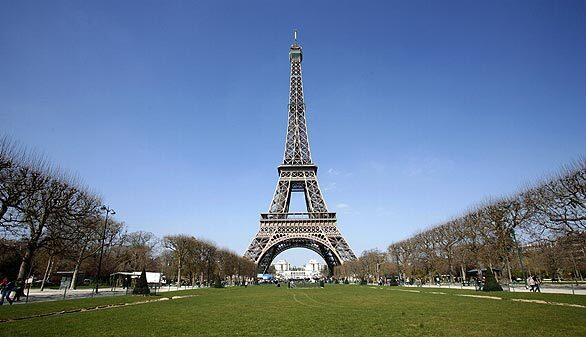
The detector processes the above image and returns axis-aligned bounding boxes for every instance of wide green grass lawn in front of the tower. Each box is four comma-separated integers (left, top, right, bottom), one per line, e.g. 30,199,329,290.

0,285,586,337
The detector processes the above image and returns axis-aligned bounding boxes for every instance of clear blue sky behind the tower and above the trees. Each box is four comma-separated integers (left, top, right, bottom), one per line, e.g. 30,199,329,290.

0,0,586,264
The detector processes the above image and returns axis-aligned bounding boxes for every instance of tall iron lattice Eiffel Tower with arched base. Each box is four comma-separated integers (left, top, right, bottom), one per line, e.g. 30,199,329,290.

244,32,356,273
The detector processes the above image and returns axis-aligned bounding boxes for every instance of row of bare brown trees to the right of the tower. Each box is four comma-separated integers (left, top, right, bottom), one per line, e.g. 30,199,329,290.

338,160,586,281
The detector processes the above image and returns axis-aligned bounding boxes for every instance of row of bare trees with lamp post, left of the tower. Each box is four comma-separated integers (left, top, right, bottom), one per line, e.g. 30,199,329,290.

0,138,254,288
